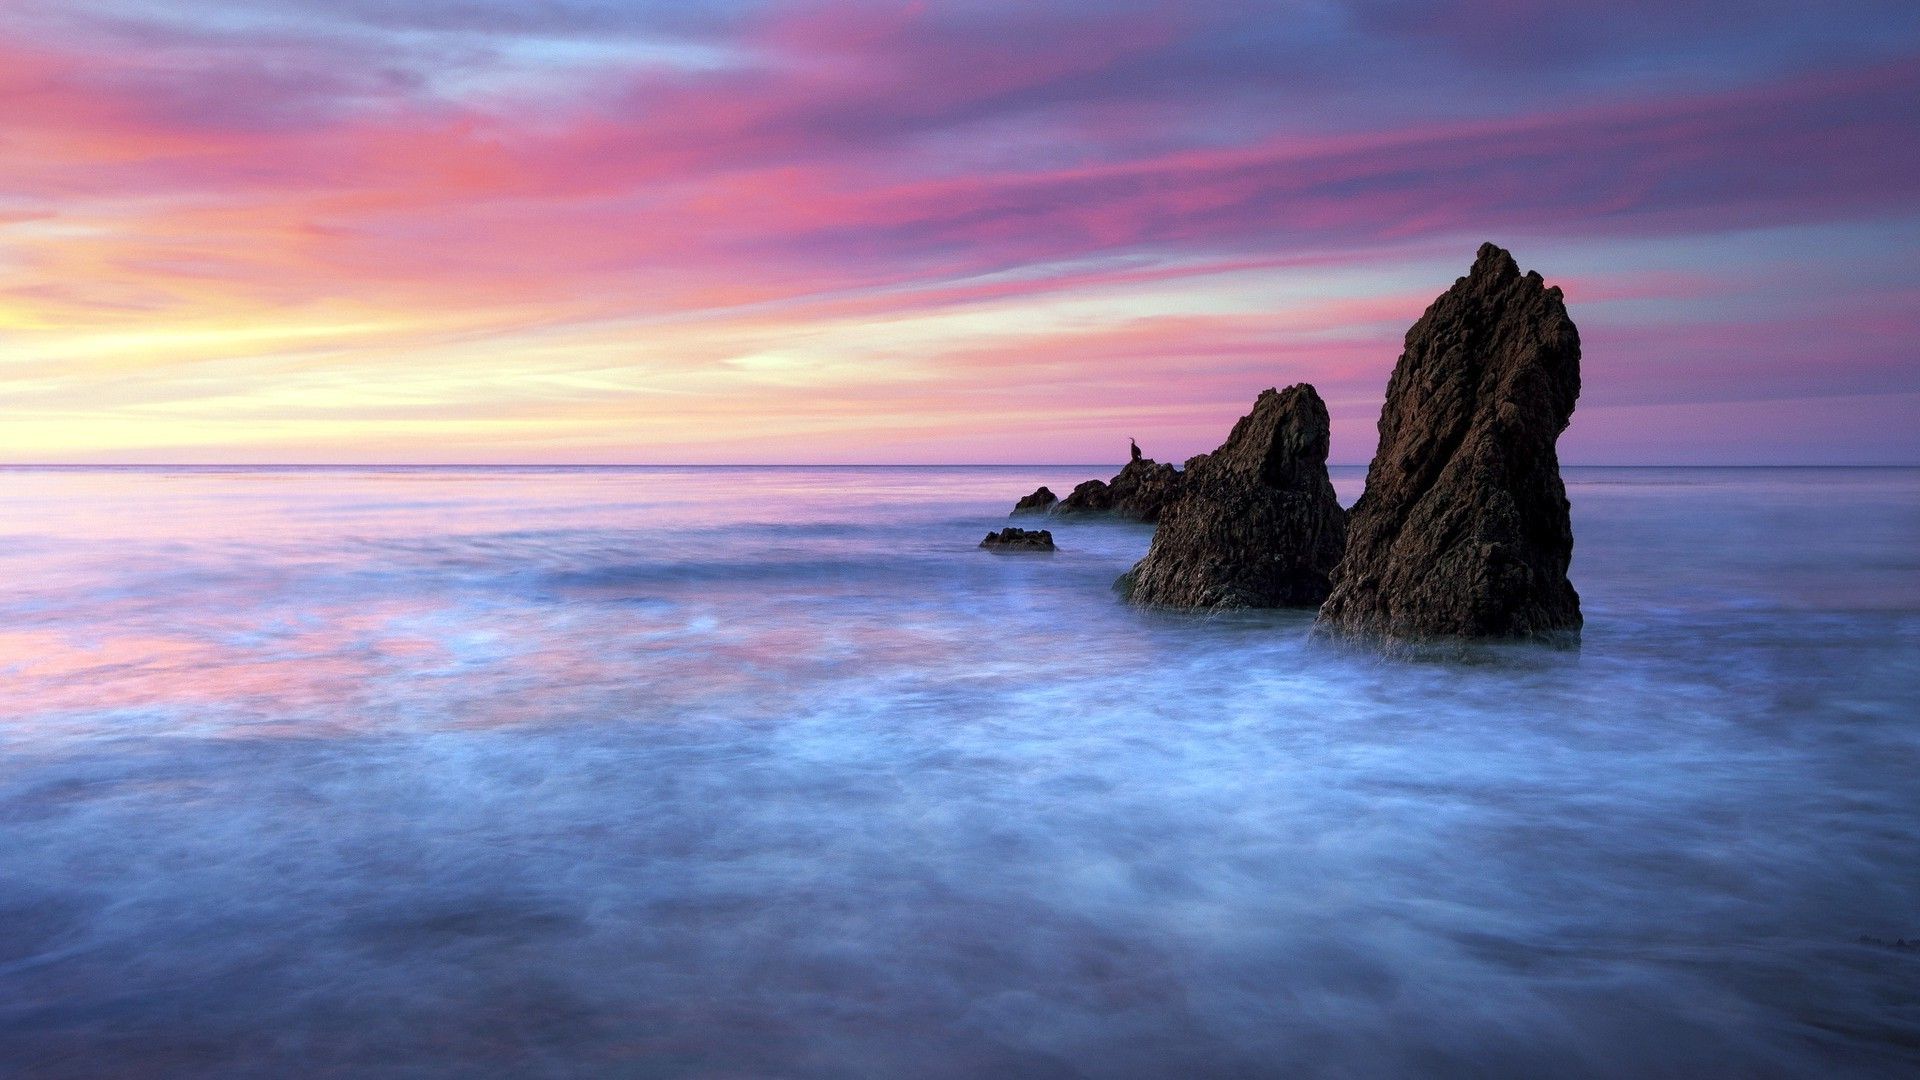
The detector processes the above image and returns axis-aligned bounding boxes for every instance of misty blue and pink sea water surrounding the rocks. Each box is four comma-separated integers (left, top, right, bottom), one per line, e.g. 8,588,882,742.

0,467,1920,1078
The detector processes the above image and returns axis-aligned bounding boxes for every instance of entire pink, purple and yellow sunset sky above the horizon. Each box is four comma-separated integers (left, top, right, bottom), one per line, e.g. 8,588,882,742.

0,0,1920,457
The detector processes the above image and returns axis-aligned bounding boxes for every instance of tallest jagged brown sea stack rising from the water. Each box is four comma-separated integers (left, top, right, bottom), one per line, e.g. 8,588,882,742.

1317,244,1580,640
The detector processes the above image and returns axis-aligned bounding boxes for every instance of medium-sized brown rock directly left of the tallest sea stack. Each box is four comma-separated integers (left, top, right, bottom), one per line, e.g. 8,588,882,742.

1119,382,1346,607
